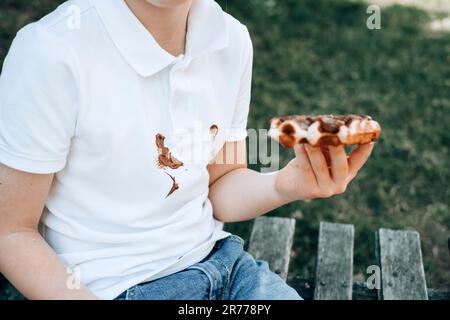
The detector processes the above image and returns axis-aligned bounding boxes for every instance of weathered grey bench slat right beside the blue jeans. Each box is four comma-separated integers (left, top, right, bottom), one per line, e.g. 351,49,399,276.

248,217,295,280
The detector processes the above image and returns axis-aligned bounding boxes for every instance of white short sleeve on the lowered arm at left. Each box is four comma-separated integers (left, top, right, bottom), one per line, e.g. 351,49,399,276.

0,25,78,174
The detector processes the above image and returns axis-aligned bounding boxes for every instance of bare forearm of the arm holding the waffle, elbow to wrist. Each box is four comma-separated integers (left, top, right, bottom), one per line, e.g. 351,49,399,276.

209,168,288,222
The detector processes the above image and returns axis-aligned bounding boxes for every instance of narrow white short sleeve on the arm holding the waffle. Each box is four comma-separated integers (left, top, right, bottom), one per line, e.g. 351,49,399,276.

226,26,253,142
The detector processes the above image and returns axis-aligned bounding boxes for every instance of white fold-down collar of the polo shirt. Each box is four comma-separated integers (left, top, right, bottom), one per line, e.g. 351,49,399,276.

93,0,228,77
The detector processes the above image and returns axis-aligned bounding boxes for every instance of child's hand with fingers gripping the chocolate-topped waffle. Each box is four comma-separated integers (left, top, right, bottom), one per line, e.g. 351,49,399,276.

275,143,374,202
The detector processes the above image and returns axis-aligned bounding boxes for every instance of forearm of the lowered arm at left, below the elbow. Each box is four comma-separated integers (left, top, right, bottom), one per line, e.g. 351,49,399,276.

0,230,96,300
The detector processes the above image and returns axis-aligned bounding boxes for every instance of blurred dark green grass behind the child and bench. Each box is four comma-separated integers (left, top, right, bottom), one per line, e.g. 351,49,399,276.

0,0,450,290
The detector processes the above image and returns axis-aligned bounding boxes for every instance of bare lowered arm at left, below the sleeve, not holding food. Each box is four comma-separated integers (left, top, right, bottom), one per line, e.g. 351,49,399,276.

0,164,96,299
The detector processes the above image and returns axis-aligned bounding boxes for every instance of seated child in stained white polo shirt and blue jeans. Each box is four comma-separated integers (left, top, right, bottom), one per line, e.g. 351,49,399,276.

0,0,373,300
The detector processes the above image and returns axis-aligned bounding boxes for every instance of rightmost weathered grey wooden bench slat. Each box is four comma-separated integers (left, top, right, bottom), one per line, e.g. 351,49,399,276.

377,229,428,300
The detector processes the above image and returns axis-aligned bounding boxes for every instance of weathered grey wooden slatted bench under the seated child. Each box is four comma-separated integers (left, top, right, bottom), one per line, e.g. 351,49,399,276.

0,217,450,300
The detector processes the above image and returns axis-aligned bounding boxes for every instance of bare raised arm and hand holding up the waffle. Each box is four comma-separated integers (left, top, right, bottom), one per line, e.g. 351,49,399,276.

208,141,373,222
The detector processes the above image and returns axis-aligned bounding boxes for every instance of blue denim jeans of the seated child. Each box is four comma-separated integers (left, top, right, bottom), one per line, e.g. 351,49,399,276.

115,235,302,300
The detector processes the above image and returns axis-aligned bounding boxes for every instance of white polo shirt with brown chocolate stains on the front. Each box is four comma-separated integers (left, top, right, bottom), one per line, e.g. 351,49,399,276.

0,0,253,299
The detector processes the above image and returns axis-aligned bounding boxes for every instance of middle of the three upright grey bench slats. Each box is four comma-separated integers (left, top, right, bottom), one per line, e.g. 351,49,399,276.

314,222,354,300
